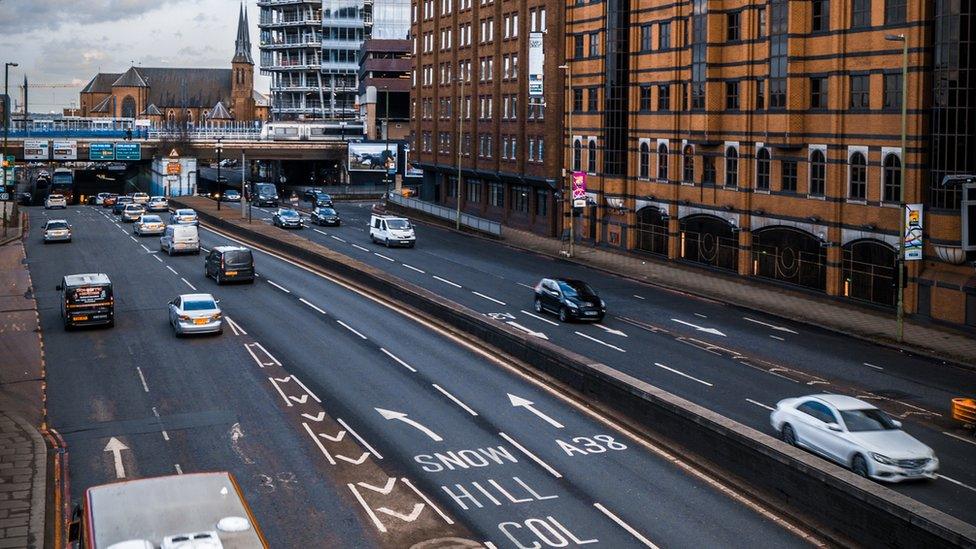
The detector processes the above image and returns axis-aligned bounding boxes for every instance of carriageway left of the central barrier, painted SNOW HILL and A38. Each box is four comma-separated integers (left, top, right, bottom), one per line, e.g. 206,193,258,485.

27,203,816,547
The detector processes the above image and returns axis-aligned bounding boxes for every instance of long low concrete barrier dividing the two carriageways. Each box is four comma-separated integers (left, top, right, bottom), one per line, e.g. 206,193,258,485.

170,199,976,549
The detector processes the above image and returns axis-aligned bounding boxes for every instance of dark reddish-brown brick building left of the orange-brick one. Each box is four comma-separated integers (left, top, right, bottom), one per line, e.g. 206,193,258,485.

411,0,565,235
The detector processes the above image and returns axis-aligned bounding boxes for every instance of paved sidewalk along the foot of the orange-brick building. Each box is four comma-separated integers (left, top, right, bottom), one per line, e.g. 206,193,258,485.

502,227,976,367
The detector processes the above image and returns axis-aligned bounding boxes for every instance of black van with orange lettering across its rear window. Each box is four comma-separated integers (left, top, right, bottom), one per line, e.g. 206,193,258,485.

57,273,115,330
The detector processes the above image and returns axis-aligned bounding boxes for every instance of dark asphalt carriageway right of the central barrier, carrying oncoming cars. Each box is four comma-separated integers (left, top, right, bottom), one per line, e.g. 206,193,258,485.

227,198,976,523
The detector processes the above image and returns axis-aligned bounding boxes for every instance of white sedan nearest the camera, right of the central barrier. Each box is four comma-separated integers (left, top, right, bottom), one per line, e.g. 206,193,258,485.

769,395,939,482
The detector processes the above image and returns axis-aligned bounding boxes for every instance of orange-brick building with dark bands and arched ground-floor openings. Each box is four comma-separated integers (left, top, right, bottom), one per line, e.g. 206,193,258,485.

565,0,976,326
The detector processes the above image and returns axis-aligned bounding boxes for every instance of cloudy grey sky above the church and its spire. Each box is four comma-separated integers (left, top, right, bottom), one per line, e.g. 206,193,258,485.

0,0,270,112
